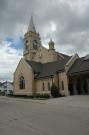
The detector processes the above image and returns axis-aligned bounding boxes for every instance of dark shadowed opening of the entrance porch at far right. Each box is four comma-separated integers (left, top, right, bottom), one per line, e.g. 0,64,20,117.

68,74,89,95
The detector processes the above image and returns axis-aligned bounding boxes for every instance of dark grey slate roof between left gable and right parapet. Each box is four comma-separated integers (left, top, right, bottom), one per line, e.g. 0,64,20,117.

26,57,70,79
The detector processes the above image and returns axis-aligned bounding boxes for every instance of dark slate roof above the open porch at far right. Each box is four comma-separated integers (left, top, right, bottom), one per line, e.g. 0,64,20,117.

68,57,89,75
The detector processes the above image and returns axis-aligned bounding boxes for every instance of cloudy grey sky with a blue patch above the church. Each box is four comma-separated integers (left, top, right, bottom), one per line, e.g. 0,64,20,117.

0,0,89,81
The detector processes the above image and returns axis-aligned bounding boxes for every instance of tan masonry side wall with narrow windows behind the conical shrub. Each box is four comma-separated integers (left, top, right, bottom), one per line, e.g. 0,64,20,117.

36,72,69,96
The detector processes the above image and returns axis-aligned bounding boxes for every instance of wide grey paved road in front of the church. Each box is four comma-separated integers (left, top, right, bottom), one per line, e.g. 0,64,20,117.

0,96,89,135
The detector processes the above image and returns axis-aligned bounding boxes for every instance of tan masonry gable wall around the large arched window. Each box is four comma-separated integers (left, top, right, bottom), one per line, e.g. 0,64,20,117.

14,60,34,95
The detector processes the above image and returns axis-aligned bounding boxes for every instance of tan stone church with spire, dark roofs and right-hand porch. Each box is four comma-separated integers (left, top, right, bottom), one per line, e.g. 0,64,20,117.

14,16,89,96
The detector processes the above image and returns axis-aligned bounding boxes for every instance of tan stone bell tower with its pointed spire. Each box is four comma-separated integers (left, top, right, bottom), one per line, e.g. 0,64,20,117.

23,15,41,60
